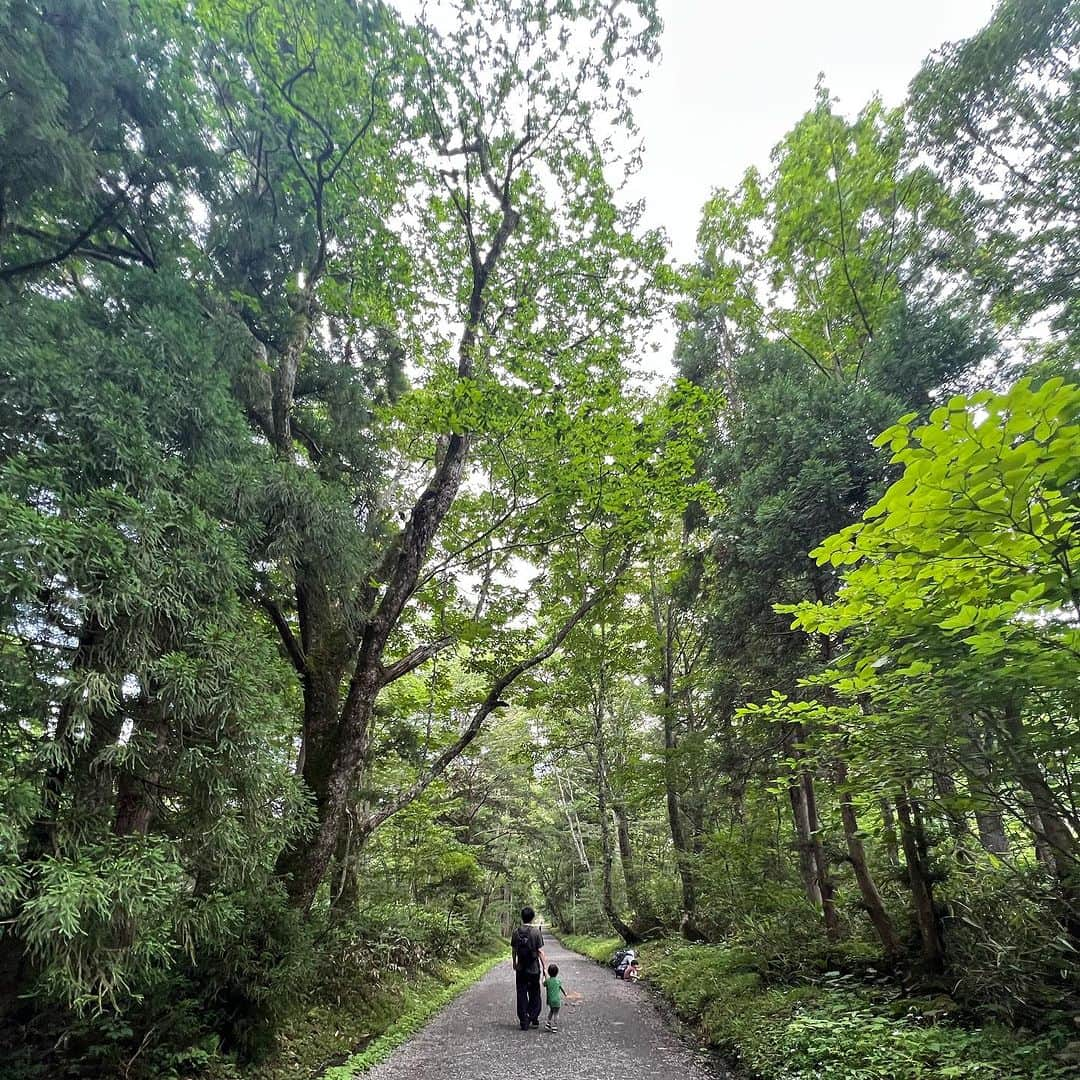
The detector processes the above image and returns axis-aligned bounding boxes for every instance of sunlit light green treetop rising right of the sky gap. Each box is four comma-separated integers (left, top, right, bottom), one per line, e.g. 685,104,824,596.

691,86,949,378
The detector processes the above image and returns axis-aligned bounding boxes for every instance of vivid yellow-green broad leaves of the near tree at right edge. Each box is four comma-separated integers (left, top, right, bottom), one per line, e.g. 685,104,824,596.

799,379,1080,694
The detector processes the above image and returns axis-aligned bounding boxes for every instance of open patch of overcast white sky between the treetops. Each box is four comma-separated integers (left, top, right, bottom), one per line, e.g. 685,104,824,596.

632,0,994,261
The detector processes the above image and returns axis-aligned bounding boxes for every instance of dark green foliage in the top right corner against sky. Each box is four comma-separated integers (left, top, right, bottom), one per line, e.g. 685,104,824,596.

912,0,1080,345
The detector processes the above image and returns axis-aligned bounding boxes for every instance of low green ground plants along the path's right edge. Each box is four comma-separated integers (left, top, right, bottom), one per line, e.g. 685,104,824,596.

563,935,1080,1080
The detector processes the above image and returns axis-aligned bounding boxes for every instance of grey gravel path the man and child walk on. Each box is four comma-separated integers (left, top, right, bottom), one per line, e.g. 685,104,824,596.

367,937,724,1080
